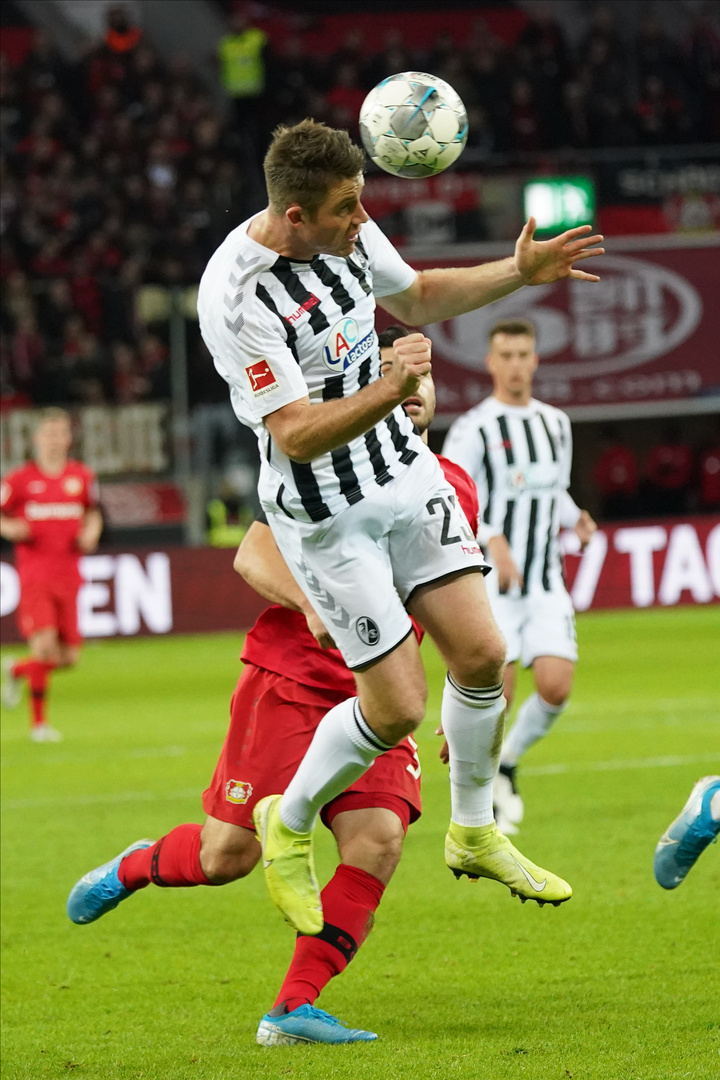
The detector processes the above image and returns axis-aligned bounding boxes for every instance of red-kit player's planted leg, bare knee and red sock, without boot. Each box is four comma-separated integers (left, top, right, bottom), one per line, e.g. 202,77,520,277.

274,795,410,1011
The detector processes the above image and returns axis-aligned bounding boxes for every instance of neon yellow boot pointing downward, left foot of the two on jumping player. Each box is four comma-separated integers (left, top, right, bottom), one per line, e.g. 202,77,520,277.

253,795,324,934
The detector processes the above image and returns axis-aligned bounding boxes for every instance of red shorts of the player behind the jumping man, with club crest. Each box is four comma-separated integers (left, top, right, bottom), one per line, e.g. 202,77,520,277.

203,664,422,829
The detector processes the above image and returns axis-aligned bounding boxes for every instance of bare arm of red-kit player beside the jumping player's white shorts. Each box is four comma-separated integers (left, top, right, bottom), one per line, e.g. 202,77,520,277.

232,522,335,648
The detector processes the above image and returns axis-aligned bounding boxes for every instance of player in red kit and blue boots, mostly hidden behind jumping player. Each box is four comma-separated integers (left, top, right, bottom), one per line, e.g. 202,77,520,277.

68,332,477,1045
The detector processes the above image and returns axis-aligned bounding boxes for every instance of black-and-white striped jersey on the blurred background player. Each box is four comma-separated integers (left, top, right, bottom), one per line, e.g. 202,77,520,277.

443,396,580,595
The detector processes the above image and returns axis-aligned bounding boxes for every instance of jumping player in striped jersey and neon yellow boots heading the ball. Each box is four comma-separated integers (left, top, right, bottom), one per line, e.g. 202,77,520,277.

198,120,602,934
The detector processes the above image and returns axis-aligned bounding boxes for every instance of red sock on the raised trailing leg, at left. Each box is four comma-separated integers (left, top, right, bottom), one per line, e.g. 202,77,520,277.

118,825,213,892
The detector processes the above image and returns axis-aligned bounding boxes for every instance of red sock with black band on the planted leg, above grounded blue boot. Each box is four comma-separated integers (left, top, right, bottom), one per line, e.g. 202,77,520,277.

275,863,385,1012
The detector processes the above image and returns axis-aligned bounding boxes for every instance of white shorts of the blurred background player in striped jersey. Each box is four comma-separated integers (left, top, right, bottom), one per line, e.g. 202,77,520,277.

488,573,578,667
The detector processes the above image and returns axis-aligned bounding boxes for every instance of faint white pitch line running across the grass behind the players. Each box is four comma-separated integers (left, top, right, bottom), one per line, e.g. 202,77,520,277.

1,754,720,810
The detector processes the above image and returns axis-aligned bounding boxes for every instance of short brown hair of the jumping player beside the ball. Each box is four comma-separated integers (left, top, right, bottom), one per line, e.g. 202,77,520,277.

263,120,365,214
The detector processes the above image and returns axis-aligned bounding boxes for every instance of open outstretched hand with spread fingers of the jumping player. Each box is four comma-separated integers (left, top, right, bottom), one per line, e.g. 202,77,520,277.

515,217,604,285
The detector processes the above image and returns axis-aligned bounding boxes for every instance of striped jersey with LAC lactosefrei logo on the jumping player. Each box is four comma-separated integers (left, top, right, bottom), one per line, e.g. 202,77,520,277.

198,218,429,522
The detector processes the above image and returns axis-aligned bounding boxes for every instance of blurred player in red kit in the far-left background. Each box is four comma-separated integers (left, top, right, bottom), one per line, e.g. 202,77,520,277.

0,408,103,742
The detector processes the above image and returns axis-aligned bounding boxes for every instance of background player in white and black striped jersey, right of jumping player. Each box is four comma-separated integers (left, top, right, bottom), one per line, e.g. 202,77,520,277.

443,320,597,833
